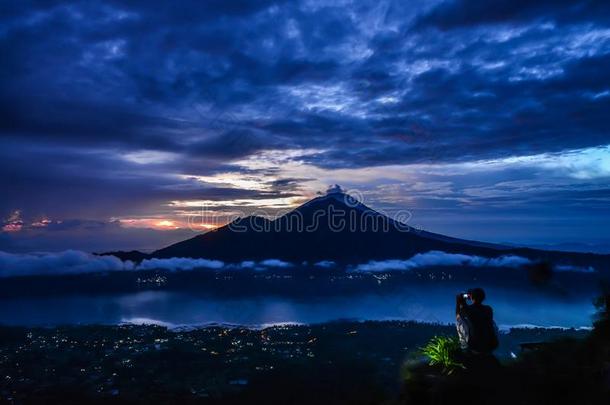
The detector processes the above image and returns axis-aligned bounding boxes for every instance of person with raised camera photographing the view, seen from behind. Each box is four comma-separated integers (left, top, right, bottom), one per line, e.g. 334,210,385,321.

455,288,498,354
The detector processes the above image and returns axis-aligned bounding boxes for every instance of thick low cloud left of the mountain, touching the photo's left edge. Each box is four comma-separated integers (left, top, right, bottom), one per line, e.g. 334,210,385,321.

0,250,134,277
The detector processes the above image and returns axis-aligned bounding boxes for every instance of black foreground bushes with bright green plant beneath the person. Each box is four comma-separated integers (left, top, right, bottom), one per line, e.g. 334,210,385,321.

400,295,610,405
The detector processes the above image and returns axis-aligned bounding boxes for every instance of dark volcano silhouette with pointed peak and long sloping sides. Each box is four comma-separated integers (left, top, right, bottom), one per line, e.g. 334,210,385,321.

103,191,610,267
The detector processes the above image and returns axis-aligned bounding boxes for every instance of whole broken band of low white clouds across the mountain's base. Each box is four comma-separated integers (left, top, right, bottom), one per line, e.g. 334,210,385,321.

0,250,595,278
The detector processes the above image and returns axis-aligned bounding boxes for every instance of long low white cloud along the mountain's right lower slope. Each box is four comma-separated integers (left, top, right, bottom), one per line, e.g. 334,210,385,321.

354,250,531,272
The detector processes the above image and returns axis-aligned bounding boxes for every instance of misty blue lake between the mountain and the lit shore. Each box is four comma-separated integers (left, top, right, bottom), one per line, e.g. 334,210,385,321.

0,287,595,328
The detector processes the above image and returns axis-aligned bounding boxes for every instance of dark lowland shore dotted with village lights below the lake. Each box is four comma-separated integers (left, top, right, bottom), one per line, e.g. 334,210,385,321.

0,322,588,404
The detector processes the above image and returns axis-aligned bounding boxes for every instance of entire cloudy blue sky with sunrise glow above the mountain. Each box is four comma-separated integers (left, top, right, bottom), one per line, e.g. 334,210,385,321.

0,0,610,252
